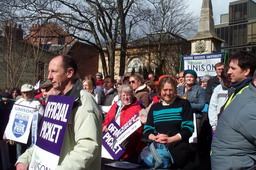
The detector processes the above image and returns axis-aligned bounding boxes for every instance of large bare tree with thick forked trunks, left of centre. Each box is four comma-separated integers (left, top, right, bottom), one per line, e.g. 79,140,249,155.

3,0,143,76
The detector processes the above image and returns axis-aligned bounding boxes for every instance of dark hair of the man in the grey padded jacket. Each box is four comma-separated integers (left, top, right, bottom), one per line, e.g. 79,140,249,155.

229,51,256,76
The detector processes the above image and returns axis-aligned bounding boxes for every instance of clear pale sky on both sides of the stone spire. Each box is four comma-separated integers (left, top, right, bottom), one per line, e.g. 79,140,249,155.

187,0,236,24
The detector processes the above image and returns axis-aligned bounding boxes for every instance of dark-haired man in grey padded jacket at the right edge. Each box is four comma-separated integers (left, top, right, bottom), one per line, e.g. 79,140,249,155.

211,52,256,170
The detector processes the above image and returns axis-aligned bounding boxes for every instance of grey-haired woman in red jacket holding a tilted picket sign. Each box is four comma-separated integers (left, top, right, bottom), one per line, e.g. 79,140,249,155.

102,85,145,163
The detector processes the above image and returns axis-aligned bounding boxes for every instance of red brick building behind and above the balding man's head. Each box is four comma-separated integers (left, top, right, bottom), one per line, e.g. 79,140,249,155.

25,23,99,78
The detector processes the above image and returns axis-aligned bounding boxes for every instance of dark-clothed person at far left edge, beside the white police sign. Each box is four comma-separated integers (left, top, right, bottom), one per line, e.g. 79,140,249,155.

0,92,14,170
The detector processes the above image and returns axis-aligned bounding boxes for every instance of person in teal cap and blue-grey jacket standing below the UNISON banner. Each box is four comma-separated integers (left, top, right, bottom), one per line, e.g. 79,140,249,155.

177,70,205,137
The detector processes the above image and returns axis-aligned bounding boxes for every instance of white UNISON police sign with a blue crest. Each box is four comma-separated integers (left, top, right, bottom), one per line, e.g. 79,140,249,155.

5,104,35,144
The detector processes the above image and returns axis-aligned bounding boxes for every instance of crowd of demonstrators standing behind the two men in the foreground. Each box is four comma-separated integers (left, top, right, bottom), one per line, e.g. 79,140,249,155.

0,50,256,169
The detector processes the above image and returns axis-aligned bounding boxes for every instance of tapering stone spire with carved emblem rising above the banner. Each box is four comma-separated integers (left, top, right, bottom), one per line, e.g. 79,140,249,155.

189,0,223,54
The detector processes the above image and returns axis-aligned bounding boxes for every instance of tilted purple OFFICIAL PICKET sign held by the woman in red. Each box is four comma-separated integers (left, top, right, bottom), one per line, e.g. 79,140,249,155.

101,115,141,160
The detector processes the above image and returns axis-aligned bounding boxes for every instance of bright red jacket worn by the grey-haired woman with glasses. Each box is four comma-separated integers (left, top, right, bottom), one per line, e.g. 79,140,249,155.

102,101,145,158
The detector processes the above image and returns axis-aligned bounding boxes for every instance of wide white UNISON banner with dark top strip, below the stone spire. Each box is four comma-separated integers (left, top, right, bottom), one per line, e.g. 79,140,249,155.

182,53,225,77
